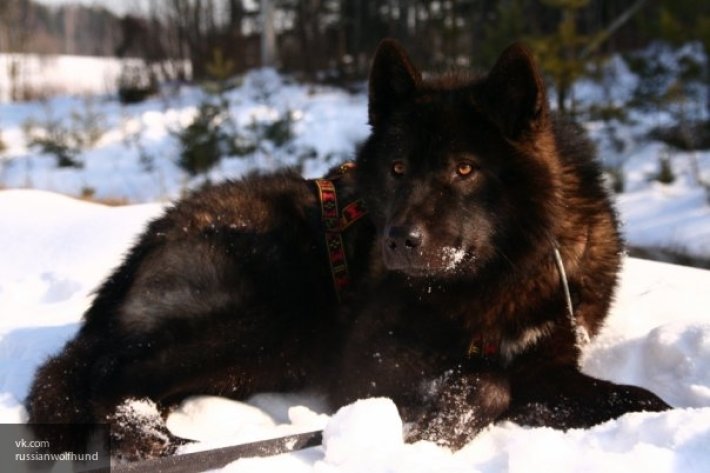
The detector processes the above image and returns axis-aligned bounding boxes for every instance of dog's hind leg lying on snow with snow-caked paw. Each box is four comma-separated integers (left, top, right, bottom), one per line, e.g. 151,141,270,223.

86,328,318,461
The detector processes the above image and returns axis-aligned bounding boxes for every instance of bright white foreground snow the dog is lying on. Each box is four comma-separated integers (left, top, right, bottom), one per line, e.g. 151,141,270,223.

0,190,710,473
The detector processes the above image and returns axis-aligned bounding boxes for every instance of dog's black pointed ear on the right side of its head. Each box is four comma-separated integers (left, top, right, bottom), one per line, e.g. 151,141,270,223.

478,43,548,140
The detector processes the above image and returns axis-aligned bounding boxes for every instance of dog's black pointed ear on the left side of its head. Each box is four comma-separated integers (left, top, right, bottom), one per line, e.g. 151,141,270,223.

368,39,421,128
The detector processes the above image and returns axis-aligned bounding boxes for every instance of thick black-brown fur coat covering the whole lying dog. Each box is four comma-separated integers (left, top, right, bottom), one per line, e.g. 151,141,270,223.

27,41,668,458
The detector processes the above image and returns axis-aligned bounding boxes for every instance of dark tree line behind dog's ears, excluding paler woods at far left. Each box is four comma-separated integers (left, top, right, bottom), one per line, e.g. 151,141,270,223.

123,0,710,79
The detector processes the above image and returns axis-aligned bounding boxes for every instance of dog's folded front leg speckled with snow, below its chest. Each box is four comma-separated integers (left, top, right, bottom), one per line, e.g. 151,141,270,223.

401,370,510,449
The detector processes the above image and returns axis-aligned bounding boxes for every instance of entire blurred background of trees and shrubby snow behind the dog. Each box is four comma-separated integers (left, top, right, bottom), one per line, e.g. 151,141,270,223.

0,0,710,267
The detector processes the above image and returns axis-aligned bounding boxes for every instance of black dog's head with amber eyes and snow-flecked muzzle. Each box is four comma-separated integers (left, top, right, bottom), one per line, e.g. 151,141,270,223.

358,40,560,278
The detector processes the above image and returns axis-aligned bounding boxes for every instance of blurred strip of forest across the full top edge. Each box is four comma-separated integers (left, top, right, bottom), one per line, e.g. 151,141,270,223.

0,0,710,86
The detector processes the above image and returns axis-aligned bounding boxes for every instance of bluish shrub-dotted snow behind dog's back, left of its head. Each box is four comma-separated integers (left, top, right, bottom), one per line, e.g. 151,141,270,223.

0,69,369,202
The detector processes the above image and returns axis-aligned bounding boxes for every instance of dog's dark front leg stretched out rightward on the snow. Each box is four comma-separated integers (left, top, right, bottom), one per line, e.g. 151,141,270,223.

505,365,670,429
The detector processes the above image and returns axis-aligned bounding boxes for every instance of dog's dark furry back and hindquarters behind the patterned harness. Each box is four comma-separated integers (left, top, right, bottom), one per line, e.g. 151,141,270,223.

27,168,371,453
